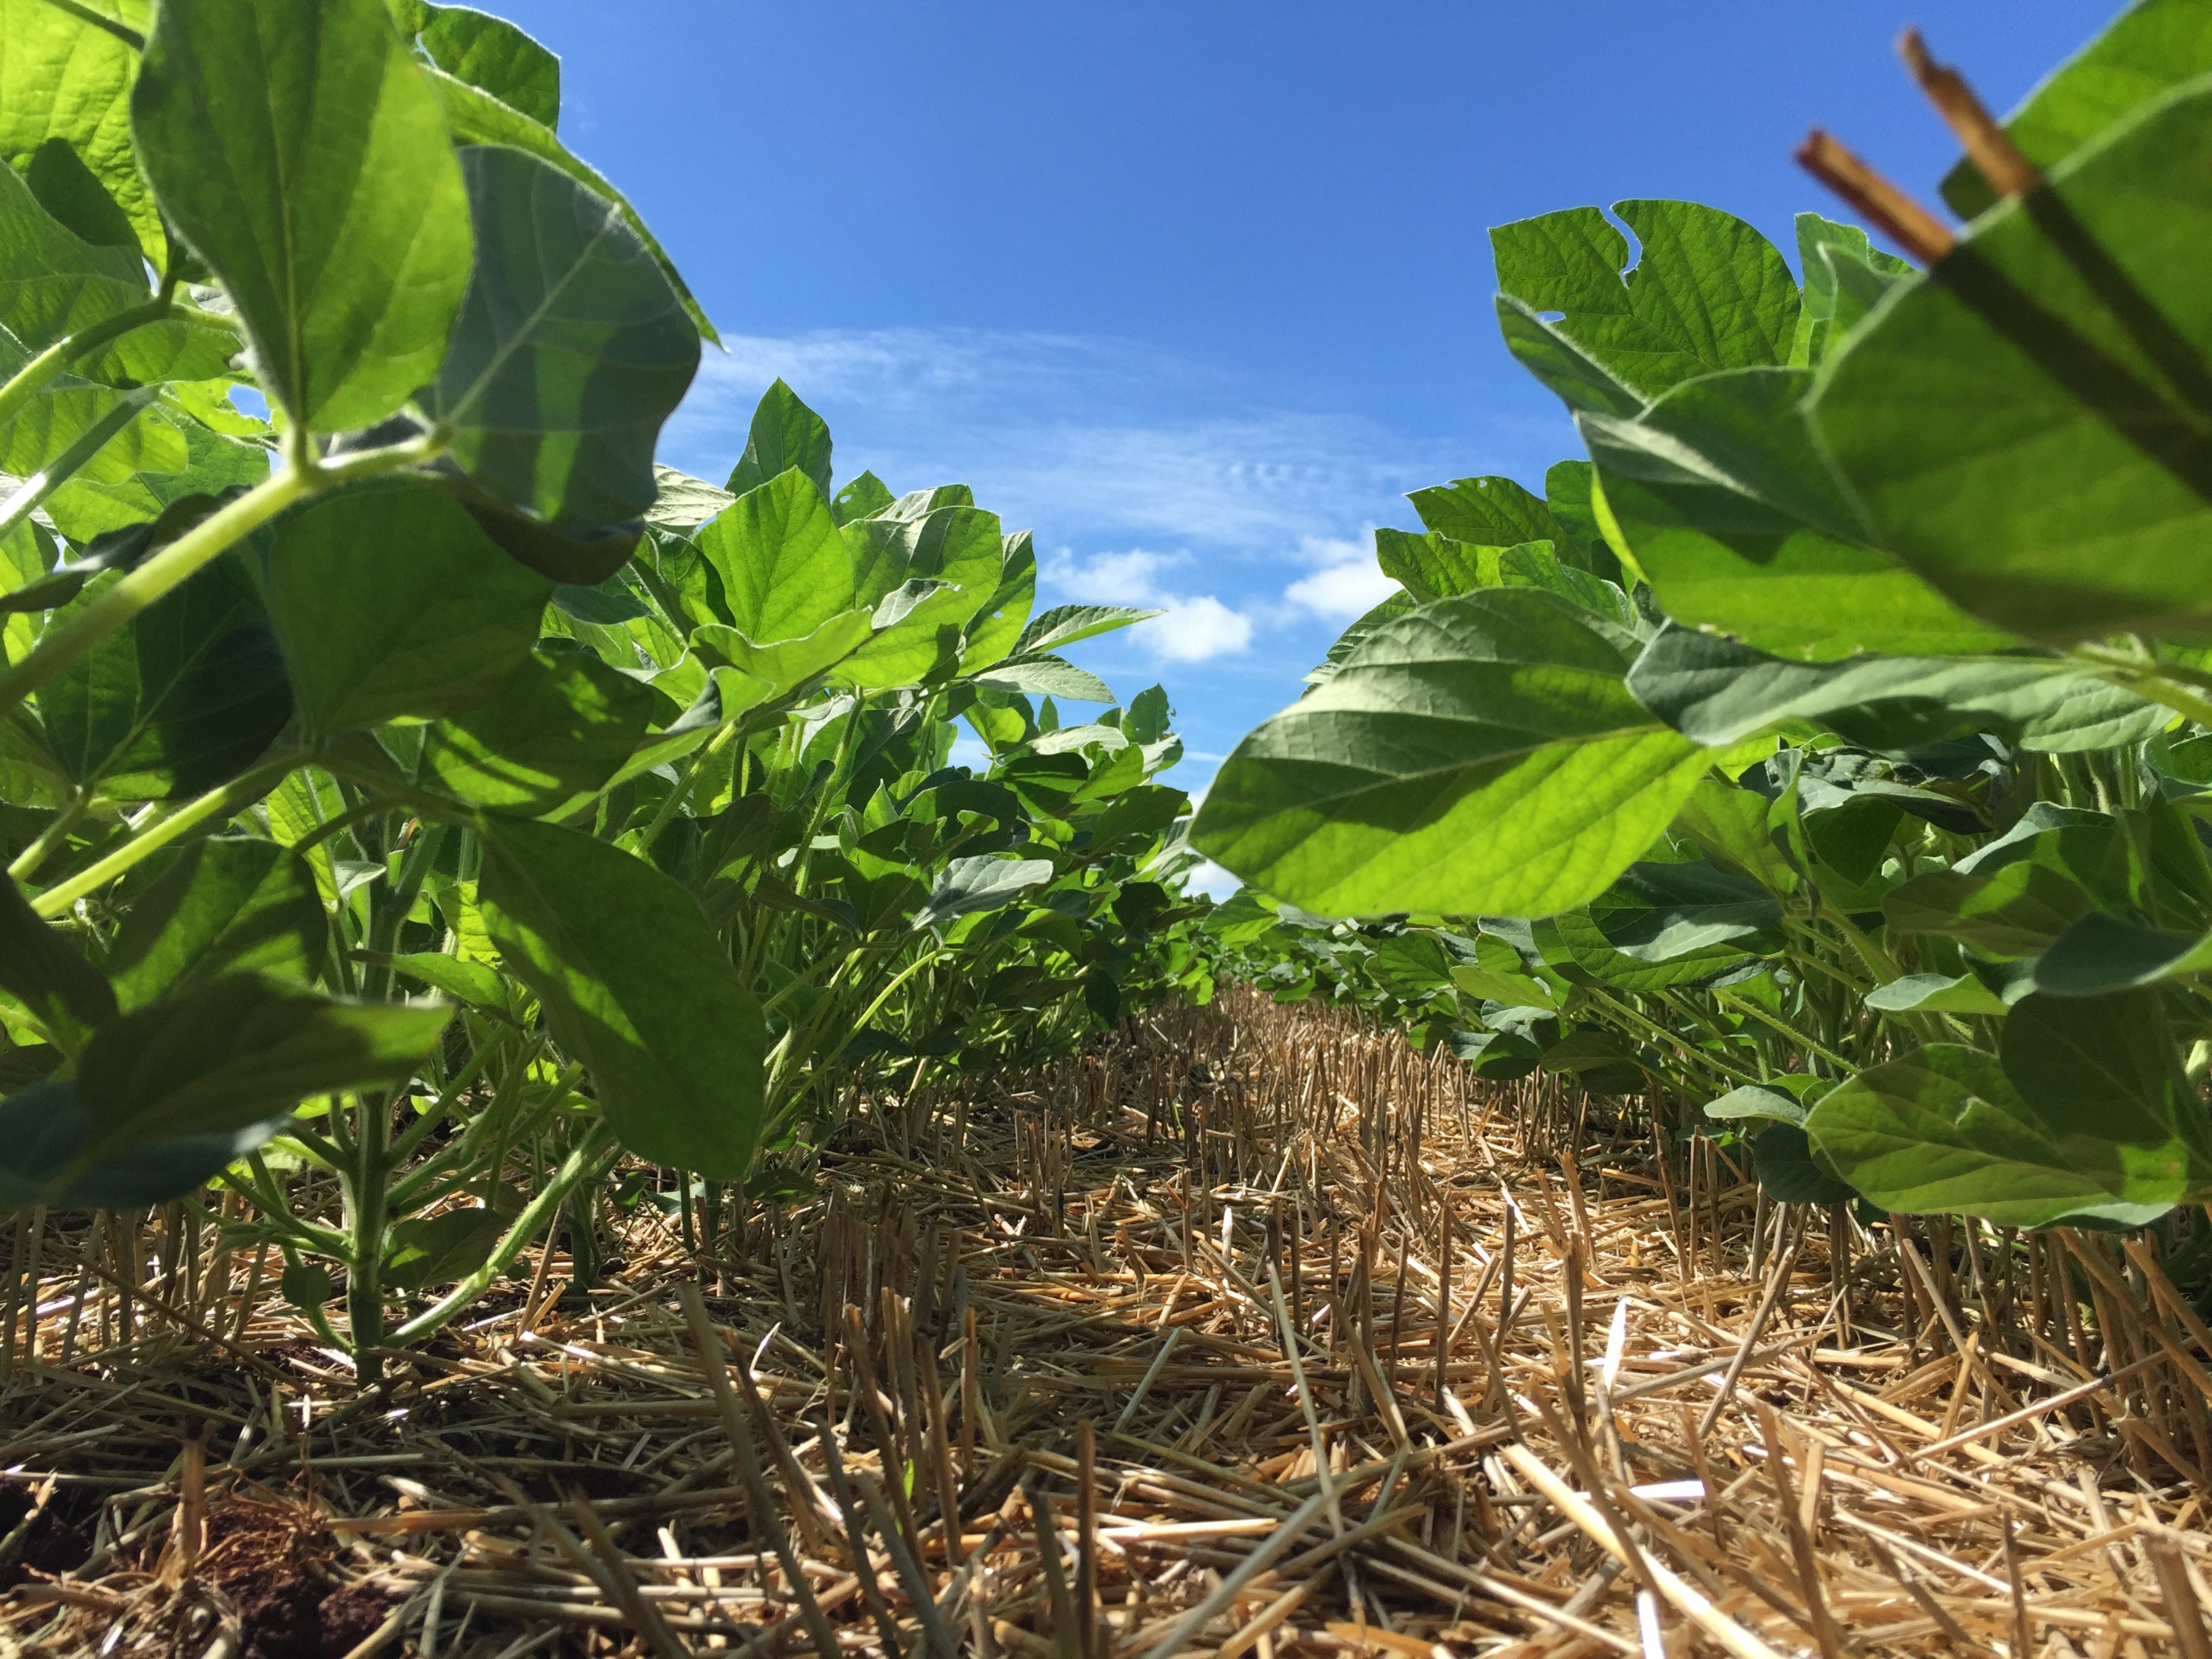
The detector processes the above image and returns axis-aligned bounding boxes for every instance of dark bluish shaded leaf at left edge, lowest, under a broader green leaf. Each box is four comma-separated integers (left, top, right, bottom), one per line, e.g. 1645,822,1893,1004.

0,1078,292,1210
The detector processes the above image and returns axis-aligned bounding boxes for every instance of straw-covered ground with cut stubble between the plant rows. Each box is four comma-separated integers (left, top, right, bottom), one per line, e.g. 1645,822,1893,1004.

0,991,2212,1659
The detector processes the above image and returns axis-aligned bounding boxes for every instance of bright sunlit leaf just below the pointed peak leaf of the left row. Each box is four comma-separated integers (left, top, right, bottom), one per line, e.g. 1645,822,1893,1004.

693,471,858,646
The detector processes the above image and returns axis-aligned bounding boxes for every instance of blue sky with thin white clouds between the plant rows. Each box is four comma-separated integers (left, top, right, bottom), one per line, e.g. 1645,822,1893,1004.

489,0,2110,844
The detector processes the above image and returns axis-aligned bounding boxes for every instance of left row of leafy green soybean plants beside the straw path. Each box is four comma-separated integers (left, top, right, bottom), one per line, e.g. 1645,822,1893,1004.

0,0,1210,1376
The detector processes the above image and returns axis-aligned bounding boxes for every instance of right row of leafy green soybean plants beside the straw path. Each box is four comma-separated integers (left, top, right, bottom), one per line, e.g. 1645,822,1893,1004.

1192,0,2212,1228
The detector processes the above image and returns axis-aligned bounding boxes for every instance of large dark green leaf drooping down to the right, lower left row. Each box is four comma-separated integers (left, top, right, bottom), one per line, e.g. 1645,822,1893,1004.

478,819,768,1181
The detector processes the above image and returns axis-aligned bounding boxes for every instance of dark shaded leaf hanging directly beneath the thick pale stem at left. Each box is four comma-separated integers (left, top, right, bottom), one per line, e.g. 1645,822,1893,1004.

261,487,553,737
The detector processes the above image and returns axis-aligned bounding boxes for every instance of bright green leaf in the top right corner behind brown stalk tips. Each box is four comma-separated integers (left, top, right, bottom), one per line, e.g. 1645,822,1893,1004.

1942,0,2212,219
